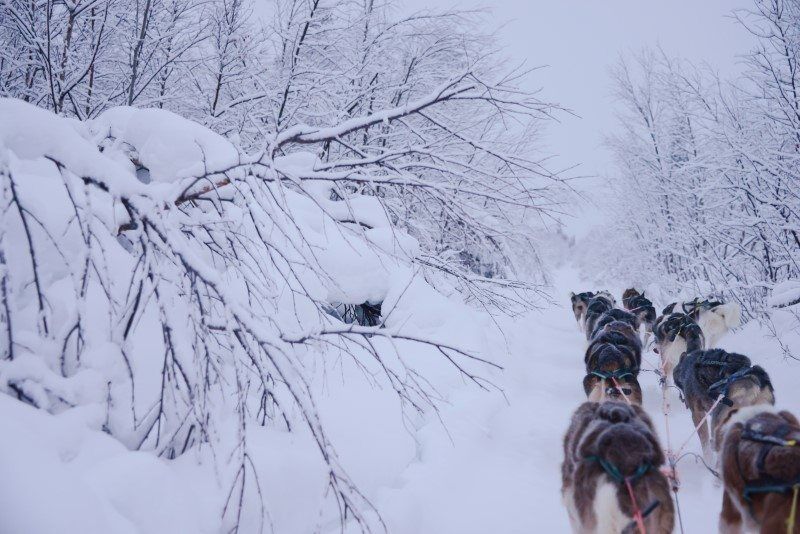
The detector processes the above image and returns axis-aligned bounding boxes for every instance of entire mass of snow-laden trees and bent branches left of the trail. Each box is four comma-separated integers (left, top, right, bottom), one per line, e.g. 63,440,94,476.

0,0,563,530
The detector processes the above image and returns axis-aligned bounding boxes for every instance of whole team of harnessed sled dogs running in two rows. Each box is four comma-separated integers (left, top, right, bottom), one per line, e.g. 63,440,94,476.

561,289,800,534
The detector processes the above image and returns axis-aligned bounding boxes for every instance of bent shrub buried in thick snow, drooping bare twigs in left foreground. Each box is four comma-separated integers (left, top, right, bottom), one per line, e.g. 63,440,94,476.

0,84,564,530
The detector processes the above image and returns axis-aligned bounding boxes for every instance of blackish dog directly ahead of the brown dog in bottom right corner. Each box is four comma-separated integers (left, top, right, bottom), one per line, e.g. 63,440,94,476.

672,349,771,460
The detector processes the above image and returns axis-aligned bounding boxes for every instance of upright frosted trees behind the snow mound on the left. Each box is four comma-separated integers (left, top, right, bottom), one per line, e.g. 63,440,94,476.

0,0,561,294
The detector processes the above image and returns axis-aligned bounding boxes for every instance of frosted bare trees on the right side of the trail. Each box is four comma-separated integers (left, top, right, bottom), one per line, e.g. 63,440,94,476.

592,0,800,322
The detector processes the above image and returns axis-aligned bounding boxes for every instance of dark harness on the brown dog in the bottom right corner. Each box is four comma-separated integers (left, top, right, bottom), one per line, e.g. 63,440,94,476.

736,425,800,534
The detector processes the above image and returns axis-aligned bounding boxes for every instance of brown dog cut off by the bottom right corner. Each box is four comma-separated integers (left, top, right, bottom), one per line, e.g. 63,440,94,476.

719,406,800,534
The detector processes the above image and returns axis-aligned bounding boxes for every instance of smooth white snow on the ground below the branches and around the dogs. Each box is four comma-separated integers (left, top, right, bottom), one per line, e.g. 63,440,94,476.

0,262,800,534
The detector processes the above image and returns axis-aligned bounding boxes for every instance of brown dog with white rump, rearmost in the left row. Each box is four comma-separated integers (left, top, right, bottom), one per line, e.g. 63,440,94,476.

561,401,674,534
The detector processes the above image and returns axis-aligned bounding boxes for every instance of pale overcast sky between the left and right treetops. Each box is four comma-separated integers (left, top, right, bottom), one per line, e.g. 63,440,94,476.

401,0,753,233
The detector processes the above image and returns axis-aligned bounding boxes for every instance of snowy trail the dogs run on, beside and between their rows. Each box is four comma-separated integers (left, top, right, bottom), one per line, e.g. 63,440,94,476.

378,270,797,534
